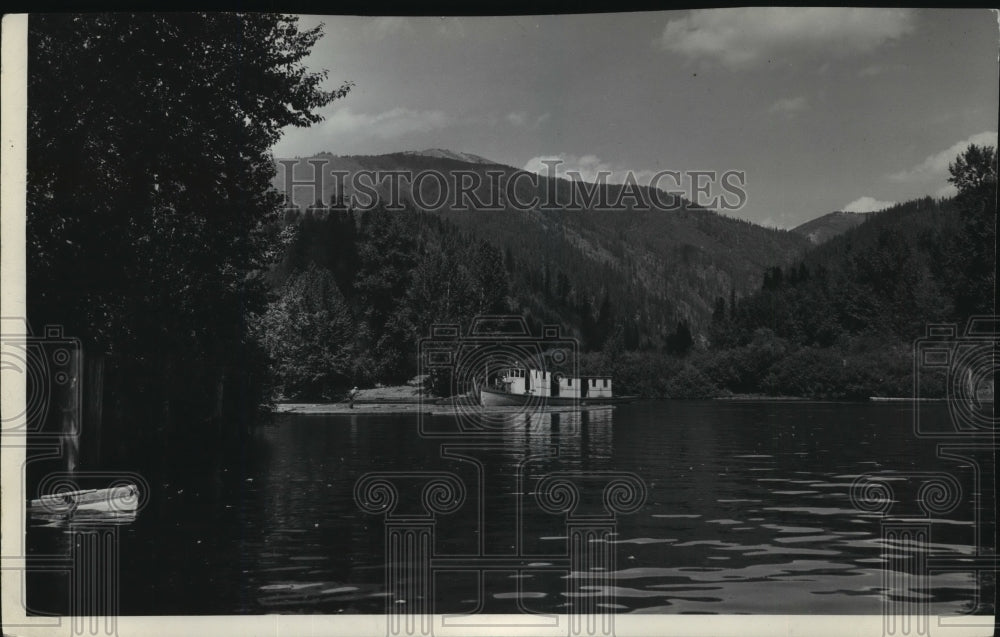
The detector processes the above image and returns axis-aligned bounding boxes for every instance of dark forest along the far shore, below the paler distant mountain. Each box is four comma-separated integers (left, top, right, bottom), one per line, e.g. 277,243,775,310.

257,147,996,398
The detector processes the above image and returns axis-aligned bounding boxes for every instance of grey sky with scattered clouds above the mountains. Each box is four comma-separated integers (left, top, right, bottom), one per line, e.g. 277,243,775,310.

274,8,1000,228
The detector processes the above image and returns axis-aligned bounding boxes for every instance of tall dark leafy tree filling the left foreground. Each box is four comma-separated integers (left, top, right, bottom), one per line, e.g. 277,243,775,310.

27,13,349,442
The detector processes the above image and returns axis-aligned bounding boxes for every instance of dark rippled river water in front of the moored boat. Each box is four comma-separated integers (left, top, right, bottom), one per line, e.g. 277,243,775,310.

28,401,995,615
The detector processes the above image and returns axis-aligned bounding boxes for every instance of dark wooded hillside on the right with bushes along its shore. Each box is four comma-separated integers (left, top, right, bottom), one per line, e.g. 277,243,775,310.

588,146,997,398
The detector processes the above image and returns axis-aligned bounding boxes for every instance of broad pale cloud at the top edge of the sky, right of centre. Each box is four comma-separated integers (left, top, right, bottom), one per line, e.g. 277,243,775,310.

657,7,916,70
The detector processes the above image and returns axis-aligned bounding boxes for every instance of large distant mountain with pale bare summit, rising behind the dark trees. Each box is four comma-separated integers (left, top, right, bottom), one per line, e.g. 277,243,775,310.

275,150,810,347
